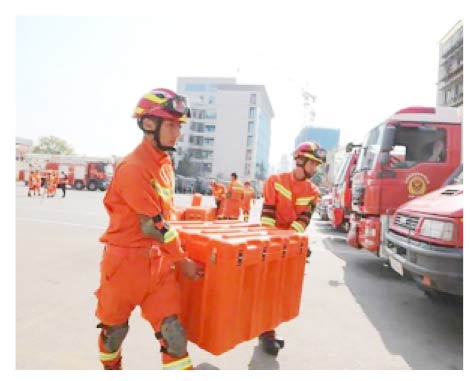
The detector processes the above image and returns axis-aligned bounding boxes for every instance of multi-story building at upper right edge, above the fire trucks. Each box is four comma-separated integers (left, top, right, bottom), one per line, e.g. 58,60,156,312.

437,21,463,107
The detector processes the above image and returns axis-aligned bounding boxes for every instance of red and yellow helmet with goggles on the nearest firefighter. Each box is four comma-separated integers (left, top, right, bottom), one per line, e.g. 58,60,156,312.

133,88,191,123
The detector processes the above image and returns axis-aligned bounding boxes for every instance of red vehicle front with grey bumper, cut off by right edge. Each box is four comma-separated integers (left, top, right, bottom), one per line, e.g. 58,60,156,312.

385,165,464,295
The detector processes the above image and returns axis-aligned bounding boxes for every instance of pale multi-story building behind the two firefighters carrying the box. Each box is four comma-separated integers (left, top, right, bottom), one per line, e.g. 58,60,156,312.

175,77,274,180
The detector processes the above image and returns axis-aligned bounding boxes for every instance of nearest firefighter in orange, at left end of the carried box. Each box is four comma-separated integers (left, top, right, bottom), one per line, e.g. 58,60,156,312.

95,89,203,370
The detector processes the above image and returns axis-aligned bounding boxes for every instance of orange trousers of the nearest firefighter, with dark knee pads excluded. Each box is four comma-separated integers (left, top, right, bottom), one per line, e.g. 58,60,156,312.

95,244,192,369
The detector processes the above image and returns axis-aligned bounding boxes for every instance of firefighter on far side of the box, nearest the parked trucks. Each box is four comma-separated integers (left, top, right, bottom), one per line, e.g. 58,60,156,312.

259,142,326,356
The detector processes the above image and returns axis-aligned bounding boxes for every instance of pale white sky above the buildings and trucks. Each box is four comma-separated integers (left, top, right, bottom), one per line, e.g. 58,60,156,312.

16,1,462,169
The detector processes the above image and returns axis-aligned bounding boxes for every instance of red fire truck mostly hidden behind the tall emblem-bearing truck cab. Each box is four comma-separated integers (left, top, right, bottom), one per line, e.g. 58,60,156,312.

328,143,360,232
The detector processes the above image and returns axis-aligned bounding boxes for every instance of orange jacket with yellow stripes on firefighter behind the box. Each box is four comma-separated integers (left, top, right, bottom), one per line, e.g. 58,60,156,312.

261,172,320,233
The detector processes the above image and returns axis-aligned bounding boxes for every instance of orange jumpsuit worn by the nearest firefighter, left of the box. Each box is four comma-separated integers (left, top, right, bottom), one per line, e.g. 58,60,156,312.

95,139,192,369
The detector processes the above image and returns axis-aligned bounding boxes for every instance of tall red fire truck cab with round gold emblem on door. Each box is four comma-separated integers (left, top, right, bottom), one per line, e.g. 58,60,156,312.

347,107,462,257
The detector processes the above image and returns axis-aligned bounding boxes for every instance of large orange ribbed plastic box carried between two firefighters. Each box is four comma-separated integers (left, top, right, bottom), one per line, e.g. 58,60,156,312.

175,221,308,354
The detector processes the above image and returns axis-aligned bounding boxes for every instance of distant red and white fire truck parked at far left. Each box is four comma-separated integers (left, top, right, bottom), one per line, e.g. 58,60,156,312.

20,153,114,191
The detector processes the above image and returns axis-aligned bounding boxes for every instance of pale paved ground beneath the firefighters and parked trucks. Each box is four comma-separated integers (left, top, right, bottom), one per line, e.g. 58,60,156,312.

16,184,463,370
